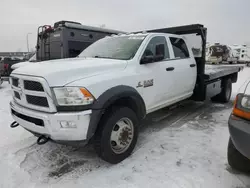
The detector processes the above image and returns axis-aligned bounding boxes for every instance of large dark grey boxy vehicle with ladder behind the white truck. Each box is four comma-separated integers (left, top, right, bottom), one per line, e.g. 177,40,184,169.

36,21,124,61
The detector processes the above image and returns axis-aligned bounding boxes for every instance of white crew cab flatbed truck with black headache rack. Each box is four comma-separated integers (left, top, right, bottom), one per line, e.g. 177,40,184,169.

10,25,240,163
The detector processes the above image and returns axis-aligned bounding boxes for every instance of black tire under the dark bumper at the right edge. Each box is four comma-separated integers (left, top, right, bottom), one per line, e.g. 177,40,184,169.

227,138,250,172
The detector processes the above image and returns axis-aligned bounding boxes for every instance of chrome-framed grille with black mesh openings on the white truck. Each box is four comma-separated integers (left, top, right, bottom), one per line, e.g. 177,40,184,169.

10,74,57,112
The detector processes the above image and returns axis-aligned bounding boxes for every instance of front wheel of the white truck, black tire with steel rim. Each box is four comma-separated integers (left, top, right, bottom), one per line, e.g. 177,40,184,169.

94,107,138,164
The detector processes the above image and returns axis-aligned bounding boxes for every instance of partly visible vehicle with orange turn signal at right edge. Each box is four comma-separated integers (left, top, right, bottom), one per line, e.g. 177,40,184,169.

227,81,250,171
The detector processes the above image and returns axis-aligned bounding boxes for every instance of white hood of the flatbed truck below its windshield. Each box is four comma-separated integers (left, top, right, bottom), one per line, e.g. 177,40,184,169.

12,58,127,87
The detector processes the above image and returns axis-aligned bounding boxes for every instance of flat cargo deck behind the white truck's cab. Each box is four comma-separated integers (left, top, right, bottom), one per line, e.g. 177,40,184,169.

205,64,243,81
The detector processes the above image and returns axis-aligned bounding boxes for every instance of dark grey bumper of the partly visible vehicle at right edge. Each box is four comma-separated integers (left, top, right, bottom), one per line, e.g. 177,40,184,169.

228,115,250,159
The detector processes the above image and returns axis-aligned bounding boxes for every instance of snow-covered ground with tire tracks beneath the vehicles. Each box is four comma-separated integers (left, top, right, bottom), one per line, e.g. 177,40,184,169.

0,68,250,188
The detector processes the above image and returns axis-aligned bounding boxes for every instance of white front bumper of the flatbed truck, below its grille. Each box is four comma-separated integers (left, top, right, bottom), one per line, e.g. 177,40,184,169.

10,101,92,142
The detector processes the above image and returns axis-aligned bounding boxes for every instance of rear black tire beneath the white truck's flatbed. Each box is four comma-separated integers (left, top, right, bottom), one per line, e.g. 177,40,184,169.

211,78,232,103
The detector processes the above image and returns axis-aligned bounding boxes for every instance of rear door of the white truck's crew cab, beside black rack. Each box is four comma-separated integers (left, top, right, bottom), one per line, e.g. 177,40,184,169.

169,37,197,100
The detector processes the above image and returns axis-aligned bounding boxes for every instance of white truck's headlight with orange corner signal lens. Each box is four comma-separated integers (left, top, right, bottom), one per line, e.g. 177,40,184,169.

53,87,94,106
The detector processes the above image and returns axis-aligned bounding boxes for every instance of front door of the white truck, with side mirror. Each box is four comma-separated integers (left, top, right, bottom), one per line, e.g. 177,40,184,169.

137,36,178,112
